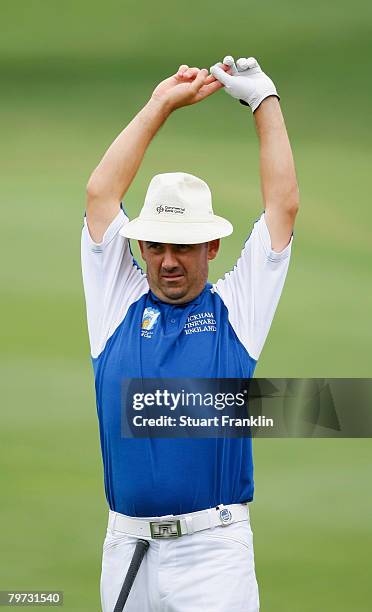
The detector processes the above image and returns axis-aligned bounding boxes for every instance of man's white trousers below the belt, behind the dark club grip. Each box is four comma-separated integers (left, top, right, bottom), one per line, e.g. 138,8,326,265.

101,510,259,612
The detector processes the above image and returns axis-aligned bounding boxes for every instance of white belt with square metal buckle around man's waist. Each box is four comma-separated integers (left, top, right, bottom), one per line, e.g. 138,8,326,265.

108,504,249,539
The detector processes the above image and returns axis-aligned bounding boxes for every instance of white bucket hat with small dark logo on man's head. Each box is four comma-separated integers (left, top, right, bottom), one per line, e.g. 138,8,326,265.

120,172,233,244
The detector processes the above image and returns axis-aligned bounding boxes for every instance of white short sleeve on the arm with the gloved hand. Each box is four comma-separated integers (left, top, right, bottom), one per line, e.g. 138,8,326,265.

213,213,293,360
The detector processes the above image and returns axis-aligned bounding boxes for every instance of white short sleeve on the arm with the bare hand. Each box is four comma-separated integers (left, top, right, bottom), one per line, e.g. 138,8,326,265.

81,209,148,357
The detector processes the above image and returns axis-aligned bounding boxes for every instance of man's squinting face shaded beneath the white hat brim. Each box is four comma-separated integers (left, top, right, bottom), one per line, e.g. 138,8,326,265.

138,240,220,304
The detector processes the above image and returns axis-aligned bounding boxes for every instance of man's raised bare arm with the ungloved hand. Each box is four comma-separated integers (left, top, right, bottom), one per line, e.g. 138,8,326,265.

86,65,222,242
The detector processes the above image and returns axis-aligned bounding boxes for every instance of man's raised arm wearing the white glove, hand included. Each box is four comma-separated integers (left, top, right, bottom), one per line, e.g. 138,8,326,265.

211,56,299,252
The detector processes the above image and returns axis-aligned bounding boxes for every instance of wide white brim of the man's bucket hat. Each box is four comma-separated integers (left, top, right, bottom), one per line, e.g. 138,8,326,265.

119,215,234,244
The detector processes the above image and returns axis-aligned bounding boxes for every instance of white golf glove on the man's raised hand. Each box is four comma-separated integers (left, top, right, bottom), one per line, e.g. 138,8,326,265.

210,55,279,113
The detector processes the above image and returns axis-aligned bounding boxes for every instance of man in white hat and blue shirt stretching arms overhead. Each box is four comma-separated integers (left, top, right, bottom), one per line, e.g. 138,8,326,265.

82,58,298,612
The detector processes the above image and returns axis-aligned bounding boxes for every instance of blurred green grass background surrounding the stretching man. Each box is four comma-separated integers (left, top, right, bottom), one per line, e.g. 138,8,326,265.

0,0,372,612
